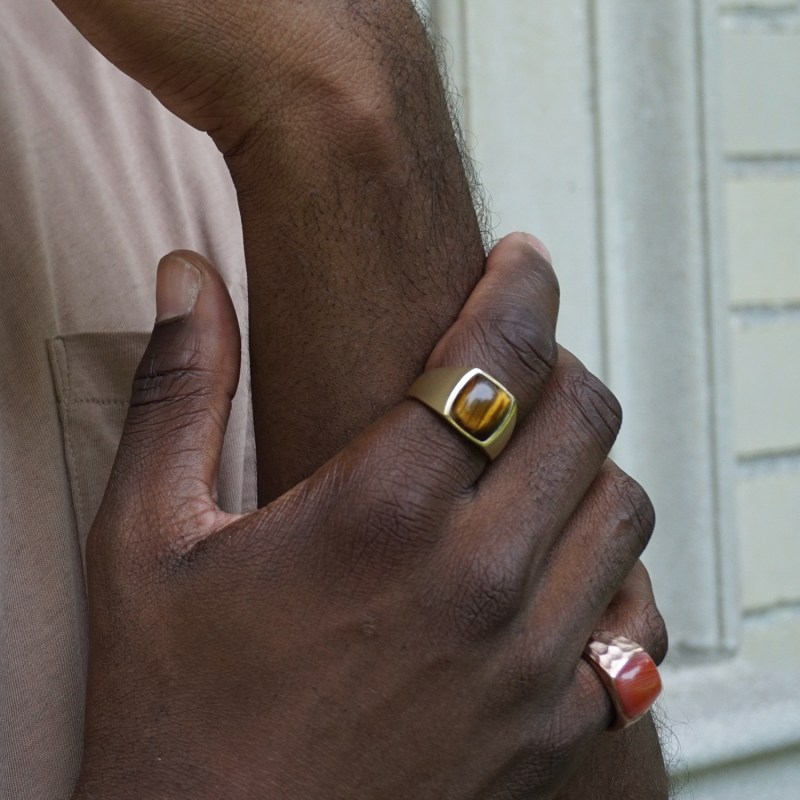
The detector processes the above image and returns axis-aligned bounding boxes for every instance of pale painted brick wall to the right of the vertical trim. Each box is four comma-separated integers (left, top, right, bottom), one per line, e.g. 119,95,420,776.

720,0,800,670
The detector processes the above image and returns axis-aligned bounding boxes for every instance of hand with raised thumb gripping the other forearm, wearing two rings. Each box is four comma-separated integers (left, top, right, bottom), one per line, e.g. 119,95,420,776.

75,236,665,800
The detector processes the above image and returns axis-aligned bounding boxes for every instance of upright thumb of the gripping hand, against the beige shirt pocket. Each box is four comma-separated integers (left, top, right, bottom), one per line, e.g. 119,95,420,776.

103,251,241,549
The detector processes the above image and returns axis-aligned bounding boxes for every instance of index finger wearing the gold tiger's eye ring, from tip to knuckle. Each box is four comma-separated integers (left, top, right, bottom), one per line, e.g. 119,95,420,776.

238,234,558,569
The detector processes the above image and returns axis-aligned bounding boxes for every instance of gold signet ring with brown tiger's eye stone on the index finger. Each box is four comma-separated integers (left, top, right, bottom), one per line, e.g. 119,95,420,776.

408,367,517,459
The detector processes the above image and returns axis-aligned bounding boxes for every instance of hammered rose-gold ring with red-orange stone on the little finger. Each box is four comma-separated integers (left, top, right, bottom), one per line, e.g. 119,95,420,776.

583,631,661,730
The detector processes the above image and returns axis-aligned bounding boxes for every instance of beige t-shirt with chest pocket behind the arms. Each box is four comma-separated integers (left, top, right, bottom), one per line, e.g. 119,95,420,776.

0,0,254,800
